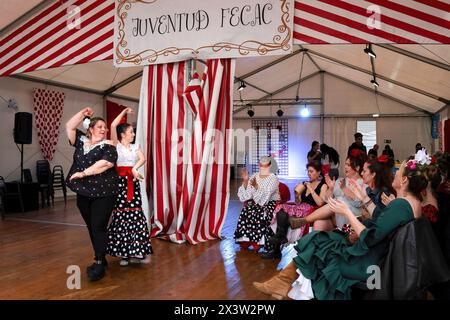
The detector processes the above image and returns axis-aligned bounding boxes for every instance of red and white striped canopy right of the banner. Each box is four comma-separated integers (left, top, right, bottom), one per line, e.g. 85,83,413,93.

294,0,450,44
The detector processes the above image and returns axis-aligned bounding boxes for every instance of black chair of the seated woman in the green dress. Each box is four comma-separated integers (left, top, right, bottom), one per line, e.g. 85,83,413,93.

352,218,450,300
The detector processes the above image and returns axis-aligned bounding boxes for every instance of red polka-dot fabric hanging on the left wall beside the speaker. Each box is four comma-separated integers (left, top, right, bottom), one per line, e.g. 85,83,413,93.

33,88,65,161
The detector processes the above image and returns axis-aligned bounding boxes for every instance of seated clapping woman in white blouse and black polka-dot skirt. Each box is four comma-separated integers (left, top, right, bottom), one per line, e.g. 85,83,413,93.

234,157,280,252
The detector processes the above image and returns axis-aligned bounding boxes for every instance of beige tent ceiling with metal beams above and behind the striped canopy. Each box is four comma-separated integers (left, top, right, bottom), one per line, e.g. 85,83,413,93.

0,4,450,113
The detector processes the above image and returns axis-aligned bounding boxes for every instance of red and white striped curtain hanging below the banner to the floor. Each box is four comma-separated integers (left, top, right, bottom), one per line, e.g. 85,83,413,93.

136,59,235,244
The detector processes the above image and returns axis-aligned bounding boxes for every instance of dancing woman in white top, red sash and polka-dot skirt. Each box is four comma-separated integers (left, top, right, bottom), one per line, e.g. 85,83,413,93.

107,108,153,266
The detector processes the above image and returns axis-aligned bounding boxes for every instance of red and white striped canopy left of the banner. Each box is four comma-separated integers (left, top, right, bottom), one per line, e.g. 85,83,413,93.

0,0,114,76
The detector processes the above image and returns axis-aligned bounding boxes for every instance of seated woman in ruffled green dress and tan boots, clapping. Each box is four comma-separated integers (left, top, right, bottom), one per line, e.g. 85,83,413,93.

253,160,428,300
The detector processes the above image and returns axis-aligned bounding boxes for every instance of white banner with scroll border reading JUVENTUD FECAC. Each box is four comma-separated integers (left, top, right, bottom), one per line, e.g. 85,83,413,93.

114,0,294,67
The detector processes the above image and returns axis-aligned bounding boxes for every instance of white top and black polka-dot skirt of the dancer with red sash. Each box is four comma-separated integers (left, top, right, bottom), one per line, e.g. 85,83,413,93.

107,143,153,258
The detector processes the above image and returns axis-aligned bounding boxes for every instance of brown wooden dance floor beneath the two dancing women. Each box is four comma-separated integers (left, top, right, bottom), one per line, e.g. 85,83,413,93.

0,182,298,300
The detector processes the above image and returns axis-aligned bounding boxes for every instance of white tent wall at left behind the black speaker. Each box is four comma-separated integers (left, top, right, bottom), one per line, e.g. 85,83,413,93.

0,78,137,196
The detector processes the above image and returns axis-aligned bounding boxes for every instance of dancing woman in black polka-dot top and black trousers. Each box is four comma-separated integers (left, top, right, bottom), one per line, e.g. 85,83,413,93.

66,108,119,281
